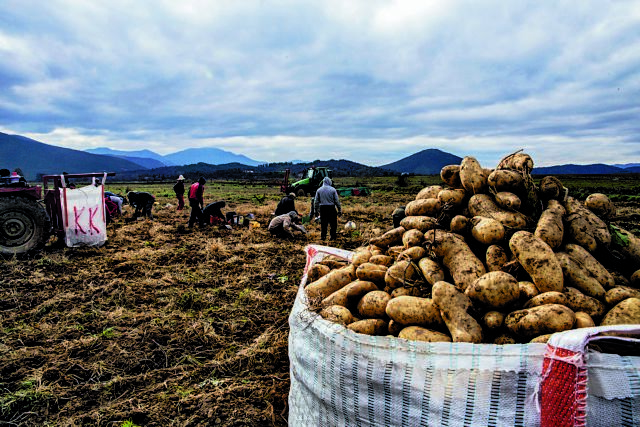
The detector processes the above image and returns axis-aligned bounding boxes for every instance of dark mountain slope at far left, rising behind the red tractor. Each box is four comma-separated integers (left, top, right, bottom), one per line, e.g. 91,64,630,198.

0,132,143,181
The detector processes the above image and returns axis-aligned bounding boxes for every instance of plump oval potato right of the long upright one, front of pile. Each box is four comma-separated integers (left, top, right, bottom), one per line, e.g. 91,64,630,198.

464,271,520,308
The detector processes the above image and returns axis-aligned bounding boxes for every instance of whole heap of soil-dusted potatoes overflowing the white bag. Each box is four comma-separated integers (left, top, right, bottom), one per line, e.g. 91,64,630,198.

306,153,640,344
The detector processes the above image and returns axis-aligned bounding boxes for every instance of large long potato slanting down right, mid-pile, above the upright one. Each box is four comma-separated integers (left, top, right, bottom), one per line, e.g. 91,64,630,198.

425,230,486,292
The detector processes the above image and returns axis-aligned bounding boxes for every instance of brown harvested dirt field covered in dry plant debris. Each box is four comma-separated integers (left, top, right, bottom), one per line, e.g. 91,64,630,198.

0,176,640,426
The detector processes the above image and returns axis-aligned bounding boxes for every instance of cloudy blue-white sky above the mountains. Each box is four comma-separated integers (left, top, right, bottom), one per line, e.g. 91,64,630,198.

0,0,640,167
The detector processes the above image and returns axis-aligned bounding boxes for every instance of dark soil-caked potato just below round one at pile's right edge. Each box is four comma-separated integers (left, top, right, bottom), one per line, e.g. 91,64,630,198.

564,197,611,252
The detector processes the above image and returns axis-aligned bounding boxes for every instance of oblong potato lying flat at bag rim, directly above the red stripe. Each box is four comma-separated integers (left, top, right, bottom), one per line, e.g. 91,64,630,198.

504,304,576,338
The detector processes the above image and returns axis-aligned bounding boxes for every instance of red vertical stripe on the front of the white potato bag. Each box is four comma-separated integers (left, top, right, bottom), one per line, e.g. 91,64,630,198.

540,345,587,427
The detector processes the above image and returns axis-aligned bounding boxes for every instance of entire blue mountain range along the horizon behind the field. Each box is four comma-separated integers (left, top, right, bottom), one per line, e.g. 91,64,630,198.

0,132,640,181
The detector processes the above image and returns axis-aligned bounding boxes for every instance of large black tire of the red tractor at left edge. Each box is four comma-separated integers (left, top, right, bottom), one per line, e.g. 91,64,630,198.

0,197,51,255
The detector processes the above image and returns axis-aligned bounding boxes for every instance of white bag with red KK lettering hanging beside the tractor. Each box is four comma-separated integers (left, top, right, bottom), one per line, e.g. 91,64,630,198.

60,179,107,247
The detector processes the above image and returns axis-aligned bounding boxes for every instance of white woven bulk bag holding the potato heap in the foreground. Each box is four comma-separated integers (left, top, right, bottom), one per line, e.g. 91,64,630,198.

289,246,640,426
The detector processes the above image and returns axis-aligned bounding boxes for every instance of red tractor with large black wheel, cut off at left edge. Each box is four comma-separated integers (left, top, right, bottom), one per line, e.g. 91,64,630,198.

0,169,115,255
